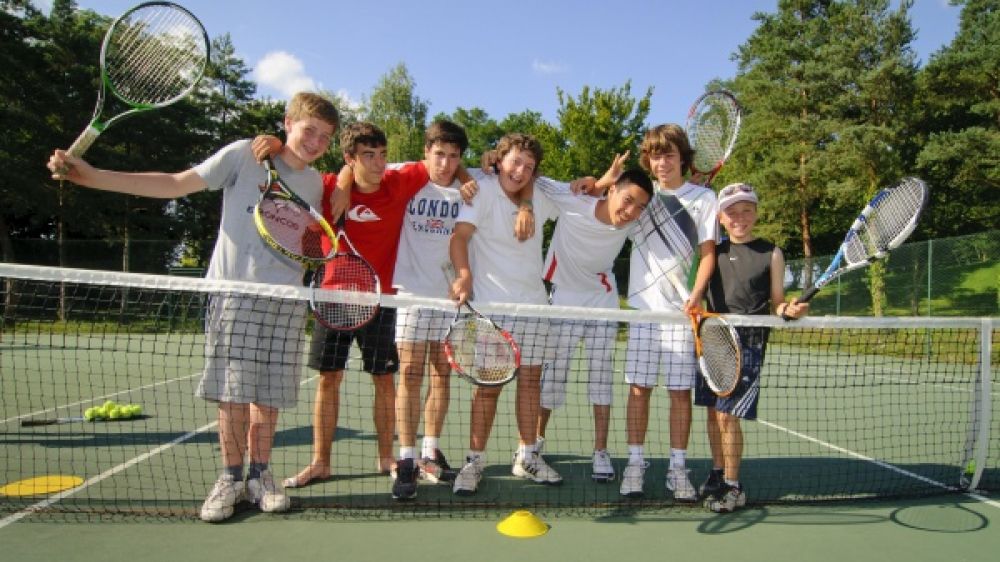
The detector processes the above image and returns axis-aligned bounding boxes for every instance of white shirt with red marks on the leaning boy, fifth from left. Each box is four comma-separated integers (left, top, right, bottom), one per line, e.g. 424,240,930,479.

535,178,635,308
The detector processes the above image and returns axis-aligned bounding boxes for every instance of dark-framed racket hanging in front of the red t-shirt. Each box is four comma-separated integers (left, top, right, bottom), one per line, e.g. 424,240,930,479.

309,230,382,331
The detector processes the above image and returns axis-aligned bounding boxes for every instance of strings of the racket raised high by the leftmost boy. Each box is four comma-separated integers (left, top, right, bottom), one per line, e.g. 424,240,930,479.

105,7,208,104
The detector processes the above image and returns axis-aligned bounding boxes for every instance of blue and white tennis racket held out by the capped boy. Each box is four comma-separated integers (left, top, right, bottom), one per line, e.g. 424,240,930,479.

799,178,928,302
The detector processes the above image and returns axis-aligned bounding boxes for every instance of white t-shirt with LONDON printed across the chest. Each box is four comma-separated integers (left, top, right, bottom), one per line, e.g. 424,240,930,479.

393,179,462,299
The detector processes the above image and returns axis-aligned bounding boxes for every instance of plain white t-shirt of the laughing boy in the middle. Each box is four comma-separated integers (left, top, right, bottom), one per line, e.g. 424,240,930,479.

457,171,556,304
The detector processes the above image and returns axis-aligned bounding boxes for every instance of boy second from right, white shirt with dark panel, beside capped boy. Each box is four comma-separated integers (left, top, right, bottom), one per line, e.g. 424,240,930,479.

621,124,718,502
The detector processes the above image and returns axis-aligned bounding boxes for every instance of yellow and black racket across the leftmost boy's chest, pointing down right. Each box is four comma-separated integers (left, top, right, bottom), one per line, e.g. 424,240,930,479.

253,158,337,266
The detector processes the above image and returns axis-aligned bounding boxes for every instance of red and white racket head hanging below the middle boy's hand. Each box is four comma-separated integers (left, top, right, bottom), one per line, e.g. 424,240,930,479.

443,303,521,386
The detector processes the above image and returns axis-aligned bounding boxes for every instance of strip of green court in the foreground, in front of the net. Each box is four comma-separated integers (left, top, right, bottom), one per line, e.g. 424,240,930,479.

0,495,1000,562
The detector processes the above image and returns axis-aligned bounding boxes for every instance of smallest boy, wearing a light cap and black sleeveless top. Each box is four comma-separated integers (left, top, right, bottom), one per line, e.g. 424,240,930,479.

695,183,809,513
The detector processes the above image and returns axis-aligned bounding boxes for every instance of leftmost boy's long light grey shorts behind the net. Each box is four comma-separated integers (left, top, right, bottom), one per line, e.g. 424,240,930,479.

195,295,308,408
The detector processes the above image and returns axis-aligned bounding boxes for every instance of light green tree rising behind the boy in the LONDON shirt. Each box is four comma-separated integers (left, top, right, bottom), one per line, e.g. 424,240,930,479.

366,63,427,162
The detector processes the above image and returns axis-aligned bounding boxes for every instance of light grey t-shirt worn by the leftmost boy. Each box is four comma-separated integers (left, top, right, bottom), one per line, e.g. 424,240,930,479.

194,140,323,285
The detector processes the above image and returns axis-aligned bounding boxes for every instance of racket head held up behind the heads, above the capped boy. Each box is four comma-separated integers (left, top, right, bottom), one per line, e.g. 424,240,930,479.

687,90,743,185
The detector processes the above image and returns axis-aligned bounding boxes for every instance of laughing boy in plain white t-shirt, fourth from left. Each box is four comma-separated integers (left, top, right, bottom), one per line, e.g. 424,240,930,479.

450,133,562,495
